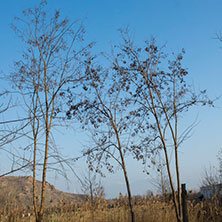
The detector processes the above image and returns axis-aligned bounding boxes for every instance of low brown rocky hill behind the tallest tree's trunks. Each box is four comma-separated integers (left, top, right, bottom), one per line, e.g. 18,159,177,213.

0,176,87,208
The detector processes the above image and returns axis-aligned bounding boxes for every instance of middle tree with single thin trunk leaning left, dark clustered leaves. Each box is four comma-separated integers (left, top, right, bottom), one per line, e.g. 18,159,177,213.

68,61,142,222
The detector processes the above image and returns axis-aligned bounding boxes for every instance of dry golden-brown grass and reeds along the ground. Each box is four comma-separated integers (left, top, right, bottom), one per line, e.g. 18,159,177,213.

0,198,222,222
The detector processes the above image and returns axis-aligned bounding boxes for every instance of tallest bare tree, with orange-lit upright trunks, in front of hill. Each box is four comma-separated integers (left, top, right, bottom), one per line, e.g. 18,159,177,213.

9,0,90,222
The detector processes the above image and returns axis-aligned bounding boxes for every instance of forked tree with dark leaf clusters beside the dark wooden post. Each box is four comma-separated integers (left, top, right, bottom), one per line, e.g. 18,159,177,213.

112,32,212,222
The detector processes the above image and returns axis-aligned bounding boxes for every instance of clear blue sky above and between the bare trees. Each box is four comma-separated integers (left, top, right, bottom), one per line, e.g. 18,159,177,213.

0,0,222,197
